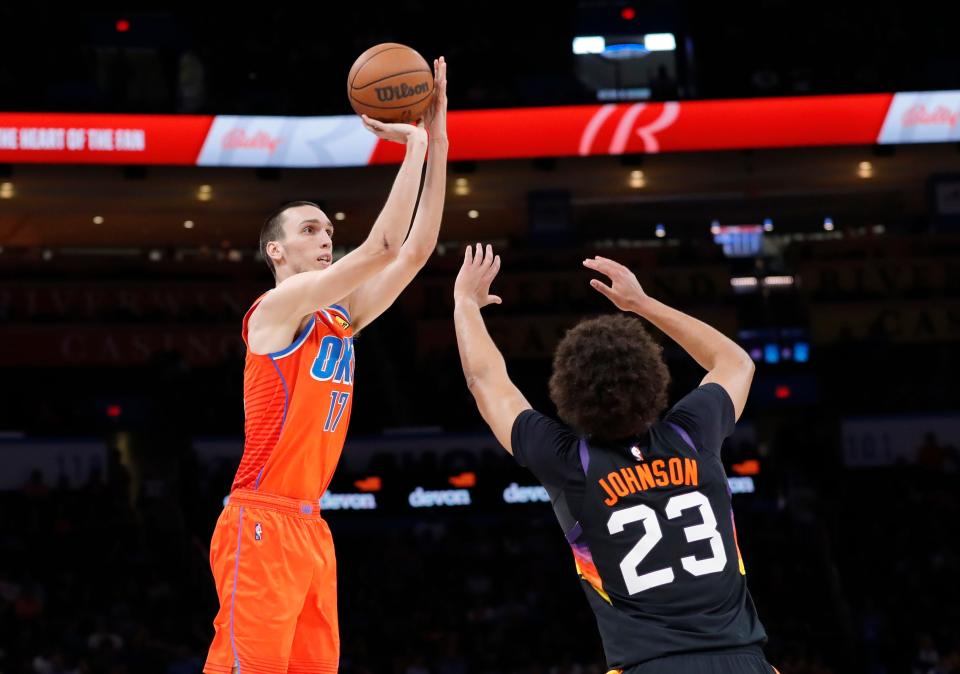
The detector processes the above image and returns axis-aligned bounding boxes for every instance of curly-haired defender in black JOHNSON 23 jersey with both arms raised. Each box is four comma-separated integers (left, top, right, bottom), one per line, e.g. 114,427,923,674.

454,244,775,674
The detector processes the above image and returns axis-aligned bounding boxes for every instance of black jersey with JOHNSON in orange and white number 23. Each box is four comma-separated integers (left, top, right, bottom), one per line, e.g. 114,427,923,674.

511,384,766,668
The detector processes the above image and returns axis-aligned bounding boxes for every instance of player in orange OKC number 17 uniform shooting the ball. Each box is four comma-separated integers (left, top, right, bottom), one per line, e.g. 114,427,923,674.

203,58,447,674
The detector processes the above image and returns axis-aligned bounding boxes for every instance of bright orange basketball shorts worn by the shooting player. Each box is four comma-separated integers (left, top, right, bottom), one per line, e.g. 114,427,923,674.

203,489,340,674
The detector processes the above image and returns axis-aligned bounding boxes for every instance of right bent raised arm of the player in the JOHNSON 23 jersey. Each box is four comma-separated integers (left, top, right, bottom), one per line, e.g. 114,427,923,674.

583,256,756,419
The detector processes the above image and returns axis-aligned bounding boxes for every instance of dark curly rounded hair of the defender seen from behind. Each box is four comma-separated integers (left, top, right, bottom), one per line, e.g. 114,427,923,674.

550,315,670,442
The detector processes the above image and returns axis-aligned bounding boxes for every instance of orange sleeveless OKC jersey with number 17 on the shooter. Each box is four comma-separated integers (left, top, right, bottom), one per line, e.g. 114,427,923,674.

233,295,354,502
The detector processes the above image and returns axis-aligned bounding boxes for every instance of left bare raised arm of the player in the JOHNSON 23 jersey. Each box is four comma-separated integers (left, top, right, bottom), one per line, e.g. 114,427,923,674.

453,243,530,454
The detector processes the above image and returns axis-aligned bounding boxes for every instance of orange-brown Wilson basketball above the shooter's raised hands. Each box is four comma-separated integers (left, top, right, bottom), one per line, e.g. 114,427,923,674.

347,42,433,124
